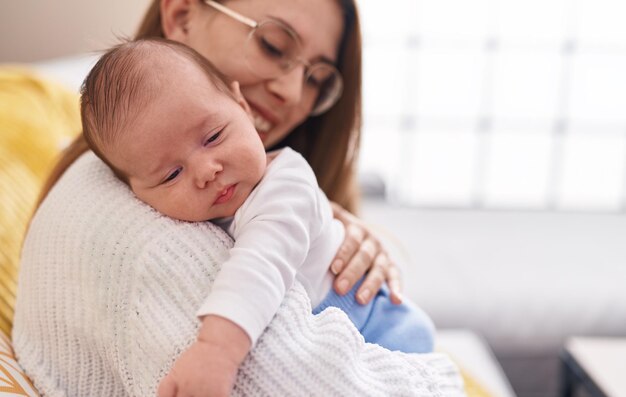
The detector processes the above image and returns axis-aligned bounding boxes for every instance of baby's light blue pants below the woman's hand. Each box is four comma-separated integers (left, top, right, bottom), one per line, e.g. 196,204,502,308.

313,279,435,353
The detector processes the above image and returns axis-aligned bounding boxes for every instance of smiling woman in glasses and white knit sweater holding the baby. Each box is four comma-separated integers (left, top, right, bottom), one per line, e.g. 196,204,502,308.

13,0,460,396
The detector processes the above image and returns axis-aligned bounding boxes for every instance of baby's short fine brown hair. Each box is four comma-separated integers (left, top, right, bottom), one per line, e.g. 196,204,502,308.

80,38,234,184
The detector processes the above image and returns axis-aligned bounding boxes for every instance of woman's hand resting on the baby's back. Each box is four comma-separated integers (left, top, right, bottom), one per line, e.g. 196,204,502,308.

330,202,402,305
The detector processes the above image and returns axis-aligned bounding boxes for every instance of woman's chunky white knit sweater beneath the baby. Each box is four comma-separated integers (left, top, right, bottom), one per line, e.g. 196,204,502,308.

13,153,463,397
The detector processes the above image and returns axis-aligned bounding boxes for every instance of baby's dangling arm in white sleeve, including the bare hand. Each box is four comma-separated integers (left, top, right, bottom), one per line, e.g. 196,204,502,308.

159,150,319,397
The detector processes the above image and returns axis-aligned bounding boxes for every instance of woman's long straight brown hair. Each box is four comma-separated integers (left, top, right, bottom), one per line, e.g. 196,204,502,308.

39,0,361,213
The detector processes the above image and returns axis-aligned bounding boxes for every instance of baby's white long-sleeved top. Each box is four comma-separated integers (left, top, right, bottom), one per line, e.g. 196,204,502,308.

198,148,344,344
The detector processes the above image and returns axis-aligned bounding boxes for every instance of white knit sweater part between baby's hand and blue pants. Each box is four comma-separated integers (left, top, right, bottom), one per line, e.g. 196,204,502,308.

233,283,464,397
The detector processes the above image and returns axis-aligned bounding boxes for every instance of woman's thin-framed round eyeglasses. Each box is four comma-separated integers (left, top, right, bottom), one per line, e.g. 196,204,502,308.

203,0,343,116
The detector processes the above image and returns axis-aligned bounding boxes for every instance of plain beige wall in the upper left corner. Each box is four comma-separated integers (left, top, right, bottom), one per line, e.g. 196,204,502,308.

0,0,150,62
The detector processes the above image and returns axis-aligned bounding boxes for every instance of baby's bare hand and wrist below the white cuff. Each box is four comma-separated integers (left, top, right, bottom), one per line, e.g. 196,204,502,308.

158,315,251,397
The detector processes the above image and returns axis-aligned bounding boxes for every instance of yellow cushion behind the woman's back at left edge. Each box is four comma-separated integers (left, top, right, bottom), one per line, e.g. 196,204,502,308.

0,66,80,334
